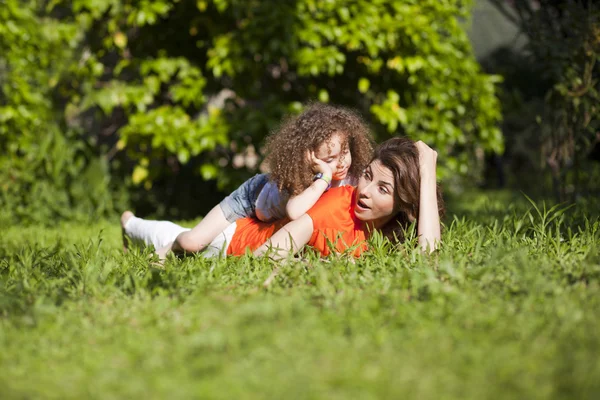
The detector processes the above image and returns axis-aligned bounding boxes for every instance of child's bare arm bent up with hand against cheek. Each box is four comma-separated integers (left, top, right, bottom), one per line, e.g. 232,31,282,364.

285,152,333,221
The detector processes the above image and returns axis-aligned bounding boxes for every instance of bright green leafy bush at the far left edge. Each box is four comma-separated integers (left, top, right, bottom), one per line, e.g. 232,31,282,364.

0,0,120,225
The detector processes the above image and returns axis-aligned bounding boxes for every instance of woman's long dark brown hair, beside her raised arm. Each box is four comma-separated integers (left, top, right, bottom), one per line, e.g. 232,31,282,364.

373,137,445,242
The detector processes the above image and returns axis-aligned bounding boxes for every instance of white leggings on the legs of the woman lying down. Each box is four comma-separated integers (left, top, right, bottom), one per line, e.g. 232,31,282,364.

125,217,236,257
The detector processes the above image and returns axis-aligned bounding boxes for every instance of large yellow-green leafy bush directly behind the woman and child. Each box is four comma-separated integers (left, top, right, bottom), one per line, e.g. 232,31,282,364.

64,0,502,188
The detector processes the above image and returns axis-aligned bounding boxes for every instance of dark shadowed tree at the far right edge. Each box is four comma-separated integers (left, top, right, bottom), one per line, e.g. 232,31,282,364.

493,0,600,201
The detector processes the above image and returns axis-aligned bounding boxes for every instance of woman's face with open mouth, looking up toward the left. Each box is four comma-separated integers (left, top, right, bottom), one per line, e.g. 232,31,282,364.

354,160,396,228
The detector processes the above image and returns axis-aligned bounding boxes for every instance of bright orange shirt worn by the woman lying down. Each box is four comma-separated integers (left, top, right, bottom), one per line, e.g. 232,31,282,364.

227,186,367,257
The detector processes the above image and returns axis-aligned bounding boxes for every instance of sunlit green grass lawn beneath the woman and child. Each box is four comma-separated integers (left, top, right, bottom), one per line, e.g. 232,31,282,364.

0,194,600,399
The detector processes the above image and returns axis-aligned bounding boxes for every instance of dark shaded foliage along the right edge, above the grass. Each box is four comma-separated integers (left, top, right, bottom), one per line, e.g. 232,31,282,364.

490,0,600,201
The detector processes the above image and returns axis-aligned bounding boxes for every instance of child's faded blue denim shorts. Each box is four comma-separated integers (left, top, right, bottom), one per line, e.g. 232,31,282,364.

219,174,269,223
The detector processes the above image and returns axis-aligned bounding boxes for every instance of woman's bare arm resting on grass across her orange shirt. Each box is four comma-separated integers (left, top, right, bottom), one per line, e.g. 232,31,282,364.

254,214,313,260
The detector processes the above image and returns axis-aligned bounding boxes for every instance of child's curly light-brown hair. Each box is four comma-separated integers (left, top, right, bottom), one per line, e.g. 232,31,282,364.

265,103,373,196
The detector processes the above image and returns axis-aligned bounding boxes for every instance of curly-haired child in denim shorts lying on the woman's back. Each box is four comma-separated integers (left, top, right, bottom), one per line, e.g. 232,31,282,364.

121,103,372,258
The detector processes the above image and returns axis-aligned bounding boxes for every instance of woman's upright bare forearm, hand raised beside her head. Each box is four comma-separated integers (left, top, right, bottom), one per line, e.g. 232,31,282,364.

415,141,441,253
